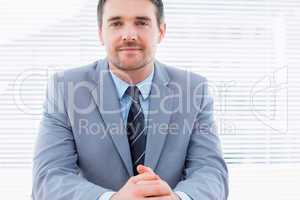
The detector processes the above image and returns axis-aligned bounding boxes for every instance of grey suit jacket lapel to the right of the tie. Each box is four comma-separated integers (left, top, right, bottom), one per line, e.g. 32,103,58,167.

145,62,173,170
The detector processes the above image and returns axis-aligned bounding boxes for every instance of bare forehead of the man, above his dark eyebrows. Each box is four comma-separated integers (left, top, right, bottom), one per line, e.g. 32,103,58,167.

103,0,156,21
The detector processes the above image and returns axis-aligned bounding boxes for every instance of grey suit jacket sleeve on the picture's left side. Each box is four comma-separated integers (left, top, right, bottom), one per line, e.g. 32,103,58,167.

32,75,109,200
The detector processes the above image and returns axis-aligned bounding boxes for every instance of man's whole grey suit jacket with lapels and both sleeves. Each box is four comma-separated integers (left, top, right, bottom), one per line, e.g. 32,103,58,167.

32,59,228,200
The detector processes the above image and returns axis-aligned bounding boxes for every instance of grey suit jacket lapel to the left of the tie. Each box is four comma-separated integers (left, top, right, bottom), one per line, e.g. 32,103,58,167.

91,59,133,176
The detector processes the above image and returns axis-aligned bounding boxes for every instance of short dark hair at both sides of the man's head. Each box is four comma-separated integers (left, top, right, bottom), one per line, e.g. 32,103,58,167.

97,0,165,26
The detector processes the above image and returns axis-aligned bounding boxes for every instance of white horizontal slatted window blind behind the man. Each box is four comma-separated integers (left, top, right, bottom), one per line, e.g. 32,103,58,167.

0,0,300,169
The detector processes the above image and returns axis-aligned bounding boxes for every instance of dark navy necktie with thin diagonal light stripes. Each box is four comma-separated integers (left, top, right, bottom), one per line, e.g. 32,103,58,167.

126,86,146,175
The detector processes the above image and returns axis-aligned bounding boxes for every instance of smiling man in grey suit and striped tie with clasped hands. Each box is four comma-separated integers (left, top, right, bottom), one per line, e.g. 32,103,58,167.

32,0,228,200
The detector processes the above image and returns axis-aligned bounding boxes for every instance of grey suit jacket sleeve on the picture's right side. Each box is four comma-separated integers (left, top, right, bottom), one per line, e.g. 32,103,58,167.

174,77,228,200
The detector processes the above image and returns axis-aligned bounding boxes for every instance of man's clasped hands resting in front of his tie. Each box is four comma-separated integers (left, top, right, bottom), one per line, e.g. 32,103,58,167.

111,165,180,200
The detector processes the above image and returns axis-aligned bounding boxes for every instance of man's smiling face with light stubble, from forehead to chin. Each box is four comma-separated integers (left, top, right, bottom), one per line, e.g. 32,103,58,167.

99,0,166,71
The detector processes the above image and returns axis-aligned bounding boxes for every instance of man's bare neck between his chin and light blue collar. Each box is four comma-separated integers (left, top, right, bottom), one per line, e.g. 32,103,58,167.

109,62,154,85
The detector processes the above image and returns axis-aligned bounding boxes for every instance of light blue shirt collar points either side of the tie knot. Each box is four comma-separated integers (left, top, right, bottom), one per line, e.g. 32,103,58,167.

109,69,154,100
